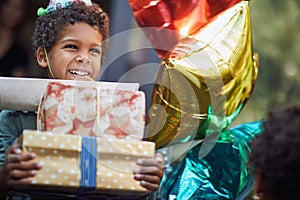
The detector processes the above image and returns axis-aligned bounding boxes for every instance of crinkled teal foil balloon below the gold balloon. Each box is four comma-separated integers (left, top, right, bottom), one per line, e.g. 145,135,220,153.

157,121,262,200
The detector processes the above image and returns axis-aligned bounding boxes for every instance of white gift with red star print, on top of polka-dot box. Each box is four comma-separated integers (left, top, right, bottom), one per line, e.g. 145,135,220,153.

37,82,145,140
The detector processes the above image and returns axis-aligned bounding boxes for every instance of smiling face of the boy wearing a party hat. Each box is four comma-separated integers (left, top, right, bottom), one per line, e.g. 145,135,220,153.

37,22,102,80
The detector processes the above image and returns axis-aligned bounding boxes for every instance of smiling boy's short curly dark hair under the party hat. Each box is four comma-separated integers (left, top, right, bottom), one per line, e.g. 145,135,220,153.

32,1,109,60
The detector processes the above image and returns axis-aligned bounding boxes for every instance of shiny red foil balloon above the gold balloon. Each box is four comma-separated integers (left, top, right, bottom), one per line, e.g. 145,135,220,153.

128,0,241,58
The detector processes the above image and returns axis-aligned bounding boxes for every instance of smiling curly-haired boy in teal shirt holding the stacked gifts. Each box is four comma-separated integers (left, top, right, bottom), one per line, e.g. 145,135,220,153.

0,1,163,198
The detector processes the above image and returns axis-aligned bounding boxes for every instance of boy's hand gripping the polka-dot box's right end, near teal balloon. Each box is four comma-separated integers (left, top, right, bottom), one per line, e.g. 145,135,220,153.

133,153,164,191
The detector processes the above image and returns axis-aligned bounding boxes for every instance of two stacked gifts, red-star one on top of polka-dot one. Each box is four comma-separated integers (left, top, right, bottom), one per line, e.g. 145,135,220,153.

12,82,155,196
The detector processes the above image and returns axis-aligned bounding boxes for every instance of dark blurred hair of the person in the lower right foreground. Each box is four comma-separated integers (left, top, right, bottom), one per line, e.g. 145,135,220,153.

250,103,300,200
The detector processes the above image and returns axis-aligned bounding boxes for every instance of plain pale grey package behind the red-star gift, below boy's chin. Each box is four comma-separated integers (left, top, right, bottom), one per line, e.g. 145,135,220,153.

0,77,139,111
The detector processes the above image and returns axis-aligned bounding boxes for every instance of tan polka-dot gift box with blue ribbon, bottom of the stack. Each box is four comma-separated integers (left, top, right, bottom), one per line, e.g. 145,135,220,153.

18,130,155,195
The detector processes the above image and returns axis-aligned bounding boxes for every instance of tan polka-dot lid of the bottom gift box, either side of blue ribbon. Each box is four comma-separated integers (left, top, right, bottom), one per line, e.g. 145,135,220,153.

18,130,155,157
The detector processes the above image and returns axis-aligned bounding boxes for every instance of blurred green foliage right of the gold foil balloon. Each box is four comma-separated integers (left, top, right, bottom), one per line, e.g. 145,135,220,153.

234,0,300,124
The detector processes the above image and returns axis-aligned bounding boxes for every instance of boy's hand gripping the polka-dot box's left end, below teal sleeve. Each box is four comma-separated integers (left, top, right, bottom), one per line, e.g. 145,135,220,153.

1,144,42,189
